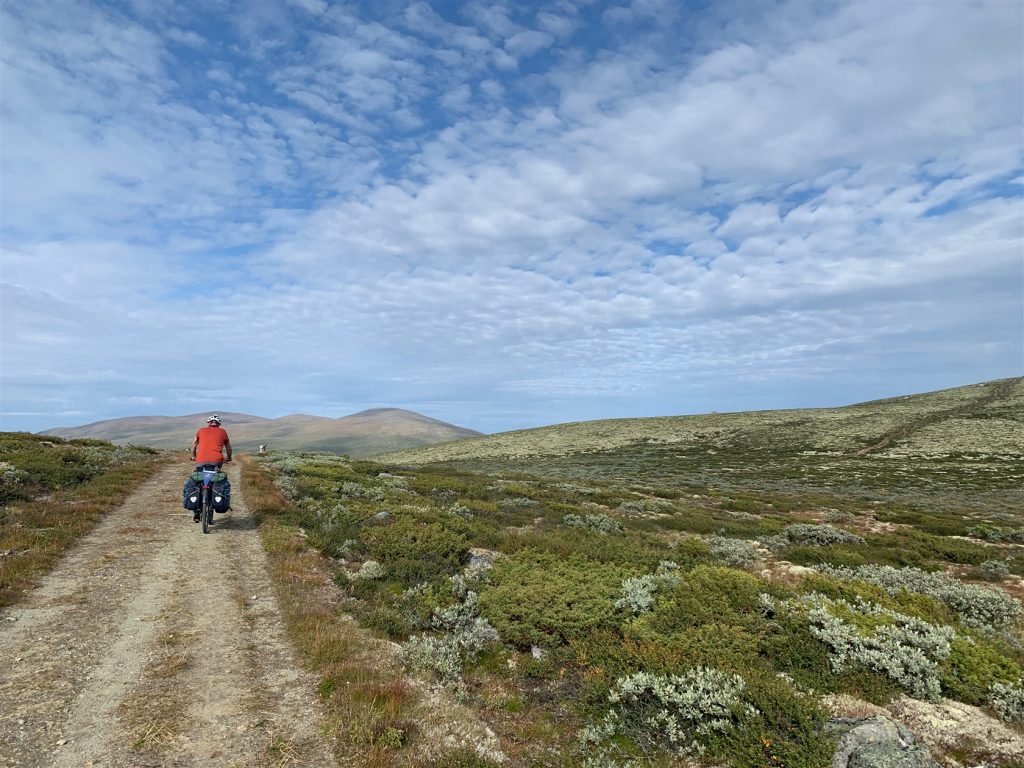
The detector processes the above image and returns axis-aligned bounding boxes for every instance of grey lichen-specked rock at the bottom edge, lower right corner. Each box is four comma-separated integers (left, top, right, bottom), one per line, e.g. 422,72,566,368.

828,716,939,768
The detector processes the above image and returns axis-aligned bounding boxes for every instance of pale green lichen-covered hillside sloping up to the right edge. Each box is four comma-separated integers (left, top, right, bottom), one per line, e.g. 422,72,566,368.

375,378,1024,504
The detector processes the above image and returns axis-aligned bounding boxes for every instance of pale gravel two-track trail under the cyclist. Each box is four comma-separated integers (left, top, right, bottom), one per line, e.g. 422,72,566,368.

0,464,334,768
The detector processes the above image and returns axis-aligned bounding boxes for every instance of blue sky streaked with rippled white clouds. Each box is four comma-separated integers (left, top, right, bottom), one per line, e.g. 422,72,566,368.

0,0,1024,432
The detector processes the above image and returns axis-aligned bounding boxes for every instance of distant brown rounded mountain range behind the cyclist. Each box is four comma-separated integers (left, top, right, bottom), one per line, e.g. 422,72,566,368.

43,408,480,457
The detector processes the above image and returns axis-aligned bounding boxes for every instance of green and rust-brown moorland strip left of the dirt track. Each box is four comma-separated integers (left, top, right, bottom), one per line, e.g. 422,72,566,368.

0,432,159,606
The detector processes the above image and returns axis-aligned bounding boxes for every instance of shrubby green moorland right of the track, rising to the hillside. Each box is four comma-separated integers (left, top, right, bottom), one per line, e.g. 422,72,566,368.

247,379,1024,768
